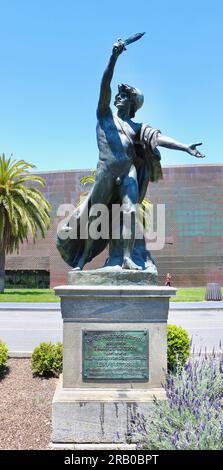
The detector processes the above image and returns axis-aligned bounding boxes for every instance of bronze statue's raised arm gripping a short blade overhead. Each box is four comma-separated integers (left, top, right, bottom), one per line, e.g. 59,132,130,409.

97,39,125,117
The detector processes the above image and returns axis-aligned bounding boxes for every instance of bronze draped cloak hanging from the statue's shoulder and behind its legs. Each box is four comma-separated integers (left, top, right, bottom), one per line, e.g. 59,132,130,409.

57,124,162,269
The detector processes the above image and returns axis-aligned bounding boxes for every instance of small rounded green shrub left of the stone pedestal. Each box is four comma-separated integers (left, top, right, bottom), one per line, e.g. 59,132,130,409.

31,342,63,377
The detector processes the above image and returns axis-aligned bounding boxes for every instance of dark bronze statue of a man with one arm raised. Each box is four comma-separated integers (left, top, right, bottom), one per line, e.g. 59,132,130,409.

57,39,204,270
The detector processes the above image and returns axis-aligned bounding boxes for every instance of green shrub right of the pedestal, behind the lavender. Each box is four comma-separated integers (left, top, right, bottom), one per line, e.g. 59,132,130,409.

167,325,190,371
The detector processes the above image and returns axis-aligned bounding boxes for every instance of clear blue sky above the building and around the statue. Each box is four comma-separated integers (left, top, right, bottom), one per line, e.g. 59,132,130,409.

0,0,223,171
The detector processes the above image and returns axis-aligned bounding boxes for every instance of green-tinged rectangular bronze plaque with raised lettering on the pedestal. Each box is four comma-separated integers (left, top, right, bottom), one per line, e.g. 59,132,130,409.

82,330,149,381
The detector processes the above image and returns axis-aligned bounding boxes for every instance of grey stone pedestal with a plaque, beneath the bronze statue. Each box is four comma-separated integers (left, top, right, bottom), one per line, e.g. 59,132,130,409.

52,285,176,448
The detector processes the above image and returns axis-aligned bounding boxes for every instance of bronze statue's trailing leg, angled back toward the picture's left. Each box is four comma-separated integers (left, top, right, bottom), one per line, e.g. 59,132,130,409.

73,171,114,271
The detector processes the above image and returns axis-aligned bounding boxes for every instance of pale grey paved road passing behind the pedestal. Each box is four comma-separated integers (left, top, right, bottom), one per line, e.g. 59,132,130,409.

0,302,223,351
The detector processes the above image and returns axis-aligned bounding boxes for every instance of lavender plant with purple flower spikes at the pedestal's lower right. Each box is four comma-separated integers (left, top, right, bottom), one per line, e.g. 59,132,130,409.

132,352,223,450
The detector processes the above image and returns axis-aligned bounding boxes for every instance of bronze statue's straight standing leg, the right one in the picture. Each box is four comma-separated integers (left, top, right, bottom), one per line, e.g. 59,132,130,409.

120,165,142,270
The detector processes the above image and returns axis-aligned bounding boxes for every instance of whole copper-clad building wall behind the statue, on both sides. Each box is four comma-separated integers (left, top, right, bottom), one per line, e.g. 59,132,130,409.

7,164,223,286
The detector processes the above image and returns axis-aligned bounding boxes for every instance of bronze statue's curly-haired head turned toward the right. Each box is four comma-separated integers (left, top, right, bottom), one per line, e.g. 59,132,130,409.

114,83,144,118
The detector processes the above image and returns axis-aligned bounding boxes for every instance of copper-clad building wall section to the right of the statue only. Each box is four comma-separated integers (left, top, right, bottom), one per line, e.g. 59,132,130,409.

150,165,223,286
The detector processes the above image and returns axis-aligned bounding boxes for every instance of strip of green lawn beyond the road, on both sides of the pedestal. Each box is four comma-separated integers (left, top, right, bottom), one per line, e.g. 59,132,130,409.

0,287,223,302
